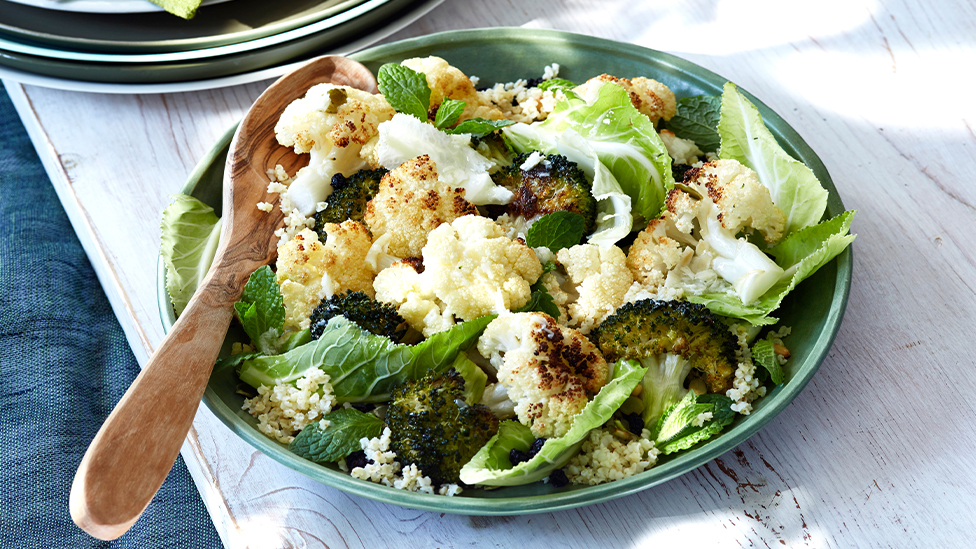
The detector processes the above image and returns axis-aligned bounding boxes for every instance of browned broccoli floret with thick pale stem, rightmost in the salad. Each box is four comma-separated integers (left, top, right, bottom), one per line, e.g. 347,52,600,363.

590,299,738,442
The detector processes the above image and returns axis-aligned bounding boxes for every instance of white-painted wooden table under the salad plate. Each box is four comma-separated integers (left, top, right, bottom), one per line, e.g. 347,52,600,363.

5,0,976,549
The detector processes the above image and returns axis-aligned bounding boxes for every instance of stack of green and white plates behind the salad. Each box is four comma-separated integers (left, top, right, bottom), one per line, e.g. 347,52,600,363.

0,0,442,92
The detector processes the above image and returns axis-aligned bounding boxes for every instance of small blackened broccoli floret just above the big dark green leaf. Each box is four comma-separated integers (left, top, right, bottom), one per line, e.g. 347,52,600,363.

309,291,408,343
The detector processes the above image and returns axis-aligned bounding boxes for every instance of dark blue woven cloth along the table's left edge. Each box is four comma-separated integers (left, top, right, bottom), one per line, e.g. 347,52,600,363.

0,86,221,549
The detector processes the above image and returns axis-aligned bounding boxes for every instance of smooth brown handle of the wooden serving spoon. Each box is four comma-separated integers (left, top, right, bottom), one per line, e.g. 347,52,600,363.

69,271,243,540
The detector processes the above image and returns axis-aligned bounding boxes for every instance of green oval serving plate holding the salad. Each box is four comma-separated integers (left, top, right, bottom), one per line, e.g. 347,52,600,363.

158,28,852,515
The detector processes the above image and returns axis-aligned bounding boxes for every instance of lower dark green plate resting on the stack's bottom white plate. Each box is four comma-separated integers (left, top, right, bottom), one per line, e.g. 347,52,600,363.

0,0,416,84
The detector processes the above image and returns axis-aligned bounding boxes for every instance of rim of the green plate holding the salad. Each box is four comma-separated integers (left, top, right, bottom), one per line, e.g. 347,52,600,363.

157,27,853,516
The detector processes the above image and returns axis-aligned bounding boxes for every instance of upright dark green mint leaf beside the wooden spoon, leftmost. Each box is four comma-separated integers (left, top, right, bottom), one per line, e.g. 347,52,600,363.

234,265,285,354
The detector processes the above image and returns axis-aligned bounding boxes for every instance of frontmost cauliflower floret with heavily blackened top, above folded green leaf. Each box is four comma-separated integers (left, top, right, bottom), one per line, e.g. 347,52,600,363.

478,313,610,438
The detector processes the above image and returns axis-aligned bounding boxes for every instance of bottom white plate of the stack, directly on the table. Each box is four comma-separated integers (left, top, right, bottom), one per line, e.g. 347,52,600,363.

0,0,444,94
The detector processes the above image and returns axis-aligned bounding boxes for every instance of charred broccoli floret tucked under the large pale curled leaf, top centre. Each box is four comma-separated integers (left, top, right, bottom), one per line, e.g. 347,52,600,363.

492,153,596,234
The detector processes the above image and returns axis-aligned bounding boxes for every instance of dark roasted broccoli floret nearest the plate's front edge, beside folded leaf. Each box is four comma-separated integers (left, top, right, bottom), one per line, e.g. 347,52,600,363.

386,368,498,484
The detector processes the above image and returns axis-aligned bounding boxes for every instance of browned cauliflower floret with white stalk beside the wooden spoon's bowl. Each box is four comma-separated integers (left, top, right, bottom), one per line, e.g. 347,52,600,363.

275,84,395,216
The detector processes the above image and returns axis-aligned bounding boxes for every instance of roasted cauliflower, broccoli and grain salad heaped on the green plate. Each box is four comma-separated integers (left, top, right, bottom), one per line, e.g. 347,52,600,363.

164,53,853,496
